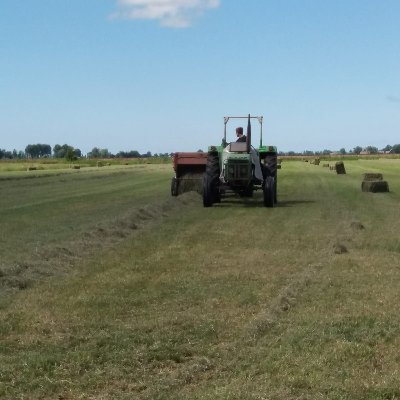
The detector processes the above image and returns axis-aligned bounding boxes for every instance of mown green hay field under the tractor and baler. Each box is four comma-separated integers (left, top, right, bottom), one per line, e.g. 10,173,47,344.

0,159,400,400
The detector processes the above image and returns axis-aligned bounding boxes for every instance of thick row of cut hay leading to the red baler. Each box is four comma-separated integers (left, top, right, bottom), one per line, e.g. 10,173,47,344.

0,192,199,296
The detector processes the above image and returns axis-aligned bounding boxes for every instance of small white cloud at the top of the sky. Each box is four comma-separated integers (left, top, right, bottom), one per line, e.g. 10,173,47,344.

112,0,220,28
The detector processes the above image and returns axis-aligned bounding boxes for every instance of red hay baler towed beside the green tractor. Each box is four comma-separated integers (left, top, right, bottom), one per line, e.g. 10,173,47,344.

171,151,207,196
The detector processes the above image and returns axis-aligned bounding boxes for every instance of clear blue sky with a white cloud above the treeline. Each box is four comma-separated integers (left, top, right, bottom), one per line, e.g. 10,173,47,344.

0,0,400,153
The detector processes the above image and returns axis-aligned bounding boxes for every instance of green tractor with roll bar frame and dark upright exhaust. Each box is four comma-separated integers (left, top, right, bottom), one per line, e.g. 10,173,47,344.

202,114,277,207
